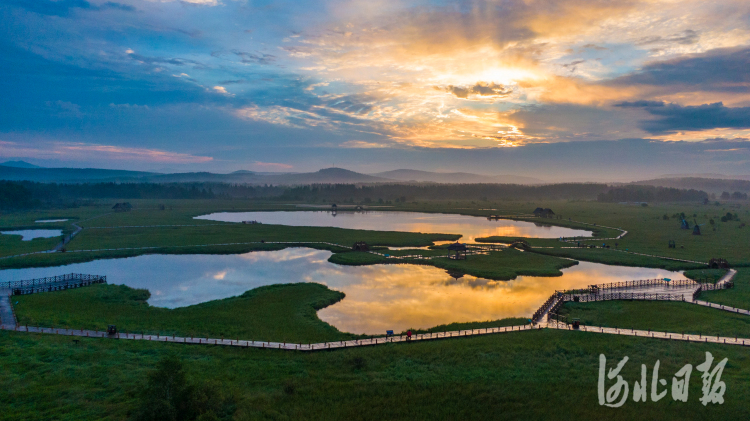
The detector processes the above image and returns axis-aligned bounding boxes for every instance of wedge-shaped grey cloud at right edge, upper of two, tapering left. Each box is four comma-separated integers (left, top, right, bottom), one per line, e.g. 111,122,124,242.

606,47,750,92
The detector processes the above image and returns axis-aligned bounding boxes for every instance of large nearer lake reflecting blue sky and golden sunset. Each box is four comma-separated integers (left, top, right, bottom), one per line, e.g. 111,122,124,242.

0,248,684,334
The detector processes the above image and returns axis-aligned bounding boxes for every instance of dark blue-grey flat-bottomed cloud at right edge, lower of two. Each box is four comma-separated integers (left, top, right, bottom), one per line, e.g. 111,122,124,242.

618,101,750,134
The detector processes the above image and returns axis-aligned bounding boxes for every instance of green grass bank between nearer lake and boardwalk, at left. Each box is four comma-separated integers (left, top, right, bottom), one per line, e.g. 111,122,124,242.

14,283,353,343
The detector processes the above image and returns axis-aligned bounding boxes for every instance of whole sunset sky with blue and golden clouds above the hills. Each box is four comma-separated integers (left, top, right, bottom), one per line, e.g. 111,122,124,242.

0,0,750,181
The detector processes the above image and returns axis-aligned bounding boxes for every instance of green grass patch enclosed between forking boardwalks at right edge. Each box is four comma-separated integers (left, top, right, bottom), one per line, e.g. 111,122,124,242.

560,301,750,338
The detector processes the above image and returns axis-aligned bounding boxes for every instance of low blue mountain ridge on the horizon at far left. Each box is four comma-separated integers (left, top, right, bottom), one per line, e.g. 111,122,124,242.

0,165,154,183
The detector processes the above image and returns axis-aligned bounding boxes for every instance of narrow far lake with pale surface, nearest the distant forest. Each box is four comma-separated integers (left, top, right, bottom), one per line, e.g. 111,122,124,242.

195,211,591,242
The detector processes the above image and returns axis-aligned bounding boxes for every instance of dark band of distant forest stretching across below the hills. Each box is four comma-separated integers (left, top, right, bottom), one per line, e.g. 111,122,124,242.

0,181,720,210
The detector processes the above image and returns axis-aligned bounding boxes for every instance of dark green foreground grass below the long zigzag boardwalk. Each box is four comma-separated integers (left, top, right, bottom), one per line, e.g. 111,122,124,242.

0,330,750,421
